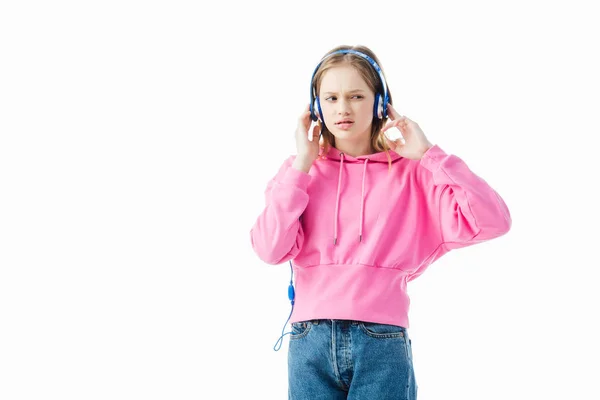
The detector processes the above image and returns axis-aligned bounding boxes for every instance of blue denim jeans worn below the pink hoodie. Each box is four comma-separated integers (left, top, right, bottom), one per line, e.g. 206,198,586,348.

288,319,417,400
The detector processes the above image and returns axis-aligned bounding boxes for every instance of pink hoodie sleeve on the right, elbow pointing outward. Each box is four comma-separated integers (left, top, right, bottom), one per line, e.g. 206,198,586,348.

420,145,512,250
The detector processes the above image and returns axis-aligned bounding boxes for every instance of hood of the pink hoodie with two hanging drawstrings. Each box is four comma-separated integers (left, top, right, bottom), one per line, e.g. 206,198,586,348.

324,146,402,245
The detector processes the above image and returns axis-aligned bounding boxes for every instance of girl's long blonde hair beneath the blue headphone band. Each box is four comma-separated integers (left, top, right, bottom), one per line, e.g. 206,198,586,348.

311,45,392,169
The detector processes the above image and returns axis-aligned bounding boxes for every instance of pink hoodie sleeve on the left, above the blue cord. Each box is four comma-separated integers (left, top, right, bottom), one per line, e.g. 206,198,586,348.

250,156,310,265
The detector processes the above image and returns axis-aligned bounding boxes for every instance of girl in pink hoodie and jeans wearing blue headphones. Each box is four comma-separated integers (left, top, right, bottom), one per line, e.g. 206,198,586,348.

250,46,511,400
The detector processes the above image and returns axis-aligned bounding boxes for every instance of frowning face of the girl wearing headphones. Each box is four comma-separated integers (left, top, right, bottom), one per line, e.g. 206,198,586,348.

319,65,375,142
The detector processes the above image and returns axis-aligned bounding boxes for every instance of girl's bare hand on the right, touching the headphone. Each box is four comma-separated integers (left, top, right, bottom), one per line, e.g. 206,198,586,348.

381,103,433,160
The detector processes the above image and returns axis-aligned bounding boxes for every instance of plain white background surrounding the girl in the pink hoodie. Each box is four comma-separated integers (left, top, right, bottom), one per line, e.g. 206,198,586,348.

0,1,600,400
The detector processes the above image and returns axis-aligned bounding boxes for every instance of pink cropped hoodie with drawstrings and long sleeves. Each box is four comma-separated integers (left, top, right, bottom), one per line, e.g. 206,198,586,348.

250,145,512,328
